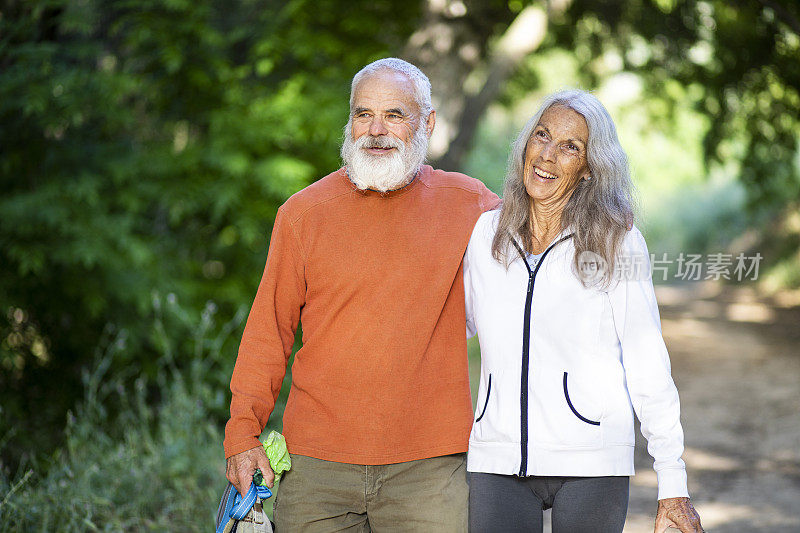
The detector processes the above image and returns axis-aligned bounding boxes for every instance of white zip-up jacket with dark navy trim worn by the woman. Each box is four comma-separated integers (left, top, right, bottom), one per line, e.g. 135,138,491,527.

464,210,689,499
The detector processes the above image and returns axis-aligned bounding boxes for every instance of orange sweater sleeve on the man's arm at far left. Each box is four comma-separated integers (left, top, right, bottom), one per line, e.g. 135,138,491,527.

223,206,306,457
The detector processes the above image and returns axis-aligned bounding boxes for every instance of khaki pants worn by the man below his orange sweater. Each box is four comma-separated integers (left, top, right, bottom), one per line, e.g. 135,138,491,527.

275,453,469,533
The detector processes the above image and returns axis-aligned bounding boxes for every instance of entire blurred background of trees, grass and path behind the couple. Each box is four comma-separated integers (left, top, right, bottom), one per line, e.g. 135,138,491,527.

0,0,800,532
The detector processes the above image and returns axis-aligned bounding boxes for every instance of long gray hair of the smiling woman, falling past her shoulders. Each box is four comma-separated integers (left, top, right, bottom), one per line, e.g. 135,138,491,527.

492,89,634,286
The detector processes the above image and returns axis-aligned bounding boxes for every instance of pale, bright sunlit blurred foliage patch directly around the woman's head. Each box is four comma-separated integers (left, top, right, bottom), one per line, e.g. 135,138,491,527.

467,44,754,257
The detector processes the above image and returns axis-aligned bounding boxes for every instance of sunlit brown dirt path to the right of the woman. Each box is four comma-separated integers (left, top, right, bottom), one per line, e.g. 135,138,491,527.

625,284,800,533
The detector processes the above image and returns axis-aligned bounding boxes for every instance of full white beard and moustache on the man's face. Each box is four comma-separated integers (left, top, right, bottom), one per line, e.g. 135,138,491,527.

342,121,428,192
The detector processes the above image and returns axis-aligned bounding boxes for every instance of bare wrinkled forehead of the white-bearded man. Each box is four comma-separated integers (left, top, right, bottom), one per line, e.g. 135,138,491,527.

351,69,419,112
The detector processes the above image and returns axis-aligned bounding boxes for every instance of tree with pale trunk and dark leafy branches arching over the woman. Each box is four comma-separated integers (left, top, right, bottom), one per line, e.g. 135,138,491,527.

404,0,800,210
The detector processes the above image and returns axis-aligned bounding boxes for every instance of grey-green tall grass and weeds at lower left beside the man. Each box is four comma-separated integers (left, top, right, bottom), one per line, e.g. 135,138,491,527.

0,298,238,532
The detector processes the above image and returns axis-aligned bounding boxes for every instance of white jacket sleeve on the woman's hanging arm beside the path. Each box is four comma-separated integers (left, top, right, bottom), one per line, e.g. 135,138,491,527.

609,228,689,499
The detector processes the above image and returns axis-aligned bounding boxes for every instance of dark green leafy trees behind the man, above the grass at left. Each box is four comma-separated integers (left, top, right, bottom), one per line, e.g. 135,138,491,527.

0,0,419,463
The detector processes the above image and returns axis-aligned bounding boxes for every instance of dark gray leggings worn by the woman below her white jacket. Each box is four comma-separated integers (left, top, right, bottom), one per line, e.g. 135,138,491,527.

467,472,629,533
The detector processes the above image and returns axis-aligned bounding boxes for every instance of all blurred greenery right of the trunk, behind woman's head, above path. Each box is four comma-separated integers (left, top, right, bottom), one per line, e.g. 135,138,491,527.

484,0,800,278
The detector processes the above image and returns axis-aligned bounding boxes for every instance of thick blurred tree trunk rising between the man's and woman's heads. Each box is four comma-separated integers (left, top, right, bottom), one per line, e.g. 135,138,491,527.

403,0,571,170
